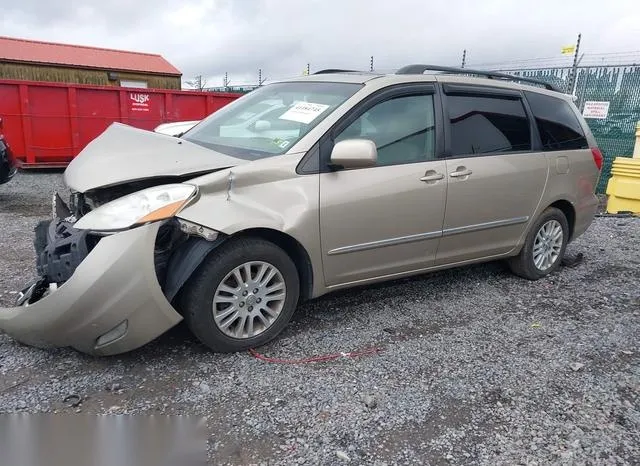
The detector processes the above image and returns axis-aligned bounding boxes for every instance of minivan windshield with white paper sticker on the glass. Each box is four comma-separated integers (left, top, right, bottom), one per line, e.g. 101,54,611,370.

183,82,362,160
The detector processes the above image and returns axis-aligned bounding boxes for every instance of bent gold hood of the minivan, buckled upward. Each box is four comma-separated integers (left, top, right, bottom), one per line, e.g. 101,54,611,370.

64,123,248,193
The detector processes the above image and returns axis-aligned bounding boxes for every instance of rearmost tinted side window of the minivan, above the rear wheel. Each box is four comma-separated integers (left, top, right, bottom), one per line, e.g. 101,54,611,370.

525,92,589,150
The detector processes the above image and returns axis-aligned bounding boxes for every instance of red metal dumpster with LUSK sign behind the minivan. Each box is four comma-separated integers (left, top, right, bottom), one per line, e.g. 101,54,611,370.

0,80,241,168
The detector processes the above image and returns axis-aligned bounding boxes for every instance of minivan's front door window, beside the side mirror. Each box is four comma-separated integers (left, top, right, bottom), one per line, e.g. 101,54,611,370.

335,95,435,165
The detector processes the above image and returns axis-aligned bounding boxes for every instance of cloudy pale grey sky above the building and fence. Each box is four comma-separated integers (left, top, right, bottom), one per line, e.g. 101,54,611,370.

0,0,640,86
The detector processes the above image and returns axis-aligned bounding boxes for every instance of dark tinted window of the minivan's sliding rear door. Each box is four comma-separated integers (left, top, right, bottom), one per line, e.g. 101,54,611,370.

447,95,531,156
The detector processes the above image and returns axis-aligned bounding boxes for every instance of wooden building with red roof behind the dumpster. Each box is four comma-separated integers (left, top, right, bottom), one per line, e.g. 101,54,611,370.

0,36,182,89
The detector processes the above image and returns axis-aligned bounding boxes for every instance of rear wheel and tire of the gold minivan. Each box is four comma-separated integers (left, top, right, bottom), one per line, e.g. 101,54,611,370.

507,207,569,280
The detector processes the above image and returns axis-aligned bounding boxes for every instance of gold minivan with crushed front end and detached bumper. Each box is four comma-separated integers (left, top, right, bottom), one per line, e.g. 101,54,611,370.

0,65,602,355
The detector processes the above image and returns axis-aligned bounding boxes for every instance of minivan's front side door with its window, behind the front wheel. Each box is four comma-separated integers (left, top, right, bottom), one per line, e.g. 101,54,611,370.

320,85,447,287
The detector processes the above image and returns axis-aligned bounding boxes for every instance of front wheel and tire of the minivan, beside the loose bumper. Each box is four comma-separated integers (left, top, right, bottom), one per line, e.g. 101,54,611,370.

179,238,300,353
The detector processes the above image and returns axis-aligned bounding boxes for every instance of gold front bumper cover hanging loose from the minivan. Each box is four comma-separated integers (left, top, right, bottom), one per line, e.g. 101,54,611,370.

0,223,182,355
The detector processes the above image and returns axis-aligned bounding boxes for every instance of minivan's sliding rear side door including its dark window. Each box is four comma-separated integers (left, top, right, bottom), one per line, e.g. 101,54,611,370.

436,84,548,265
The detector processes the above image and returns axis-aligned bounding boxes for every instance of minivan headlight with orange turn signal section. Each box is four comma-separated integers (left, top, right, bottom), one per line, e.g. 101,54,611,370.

73,184,197,231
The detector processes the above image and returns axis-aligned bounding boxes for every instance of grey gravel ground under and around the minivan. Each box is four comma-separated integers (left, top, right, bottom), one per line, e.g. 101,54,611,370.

0,173,640,465
